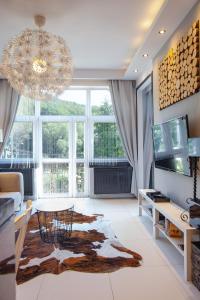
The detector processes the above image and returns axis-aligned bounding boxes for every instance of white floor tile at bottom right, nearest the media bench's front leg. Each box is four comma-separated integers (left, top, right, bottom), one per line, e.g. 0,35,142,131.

109,267,189,300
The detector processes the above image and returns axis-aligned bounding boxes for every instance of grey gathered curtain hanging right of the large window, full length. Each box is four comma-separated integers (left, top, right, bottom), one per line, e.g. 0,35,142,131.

110,80,138,195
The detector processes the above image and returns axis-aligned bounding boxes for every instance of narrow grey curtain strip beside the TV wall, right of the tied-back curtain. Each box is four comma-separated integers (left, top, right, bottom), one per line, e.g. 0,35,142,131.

142,86,153,188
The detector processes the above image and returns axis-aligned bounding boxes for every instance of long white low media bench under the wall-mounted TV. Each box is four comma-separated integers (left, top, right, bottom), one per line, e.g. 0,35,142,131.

138,189,199,281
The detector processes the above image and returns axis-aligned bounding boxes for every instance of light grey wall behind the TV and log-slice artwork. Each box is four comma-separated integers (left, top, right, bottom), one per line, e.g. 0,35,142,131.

153,3,200,206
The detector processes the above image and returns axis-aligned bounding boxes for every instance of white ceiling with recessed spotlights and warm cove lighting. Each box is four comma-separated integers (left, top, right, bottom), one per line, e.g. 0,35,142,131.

0,0,197,79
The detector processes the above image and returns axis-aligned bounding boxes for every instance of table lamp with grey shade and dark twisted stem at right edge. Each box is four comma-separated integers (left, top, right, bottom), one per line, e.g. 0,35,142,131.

188,138,200,204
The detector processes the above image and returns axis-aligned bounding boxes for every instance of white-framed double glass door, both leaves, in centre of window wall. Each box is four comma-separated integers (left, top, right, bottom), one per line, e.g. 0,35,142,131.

39,118,88,198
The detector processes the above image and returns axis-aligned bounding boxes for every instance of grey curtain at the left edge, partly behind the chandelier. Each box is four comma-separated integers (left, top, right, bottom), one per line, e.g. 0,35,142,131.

0,79,19,156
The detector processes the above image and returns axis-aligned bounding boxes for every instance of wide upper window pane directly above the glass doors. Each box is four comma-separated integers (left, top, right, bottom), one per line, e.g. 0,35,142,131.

41,90,86,116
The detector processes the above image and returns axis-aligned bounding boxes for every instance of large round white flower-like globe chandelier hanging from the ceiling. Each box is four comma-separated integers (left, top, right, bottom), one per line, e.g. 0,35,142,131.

0,15,73,100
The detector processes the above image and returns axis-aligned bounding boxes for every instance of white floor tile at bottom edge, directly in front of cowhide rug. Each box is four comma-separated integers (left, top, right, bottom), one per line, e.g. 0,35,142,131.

37,271,113,300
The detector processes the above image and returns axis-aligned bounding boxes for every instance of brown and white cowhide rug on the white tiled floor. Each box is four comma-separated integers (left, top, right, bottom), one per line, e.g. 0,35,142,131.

0,212,142,284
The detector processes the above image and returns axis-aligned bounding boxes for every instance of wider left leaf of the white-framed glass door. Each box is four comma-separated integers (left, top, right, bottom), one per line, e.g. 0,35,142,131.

41,121,72,197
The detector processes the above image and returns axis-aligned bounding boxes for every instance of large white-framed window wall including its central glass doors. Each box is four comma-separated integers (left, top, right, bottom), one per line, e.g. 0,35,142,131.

3,87,125,196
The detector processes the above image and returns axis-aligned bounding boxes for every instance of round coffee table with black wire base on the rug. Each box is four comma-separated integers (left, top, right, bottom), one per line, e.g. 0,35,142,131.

35,199,74,243
